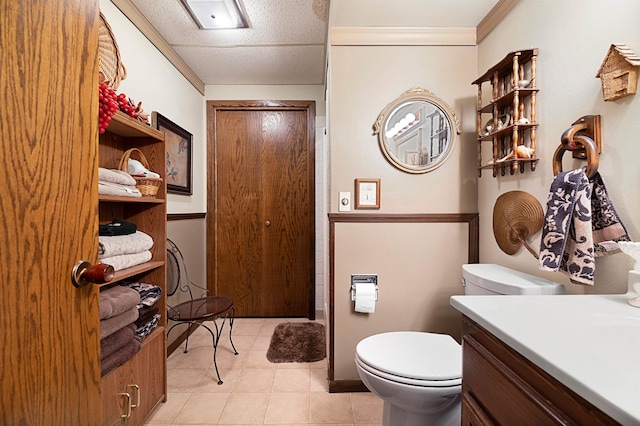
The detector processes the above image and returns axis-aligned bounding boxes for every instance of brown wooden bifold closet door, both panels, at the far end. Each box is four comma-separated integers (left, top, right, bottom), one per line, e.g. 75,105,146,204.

208,101,315,318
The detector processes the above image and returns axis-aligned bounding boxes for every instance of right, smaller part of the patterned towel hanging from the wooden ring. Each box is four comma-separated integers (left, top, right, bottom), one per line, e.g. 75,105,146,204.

590,173,631,257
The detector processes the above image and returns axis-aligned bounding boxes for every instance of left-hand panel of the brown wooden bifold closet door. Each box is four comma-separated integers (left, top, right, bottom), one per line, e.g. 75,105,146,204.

216,111,264,315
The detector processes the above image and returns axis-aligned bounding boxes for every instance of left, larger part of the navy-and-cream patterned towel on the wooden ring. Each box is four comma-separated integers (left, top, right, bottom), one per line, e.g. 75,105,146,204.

540,169,595,285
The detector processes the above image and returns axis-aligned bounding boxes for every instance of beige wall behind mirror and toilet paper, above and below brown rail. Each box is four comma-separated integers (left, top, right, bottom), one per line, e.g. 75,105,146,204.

328,35,477,381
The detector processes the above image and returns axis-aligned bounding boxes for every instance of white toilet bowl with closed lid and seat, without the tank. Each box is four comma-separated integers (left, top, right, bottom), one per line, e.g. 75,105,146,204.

355,331,462,426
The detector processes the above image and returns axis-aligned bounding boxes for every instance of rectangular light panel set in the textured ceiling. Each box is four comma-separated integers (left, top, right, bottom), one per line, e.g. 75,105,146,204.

182,0,248,30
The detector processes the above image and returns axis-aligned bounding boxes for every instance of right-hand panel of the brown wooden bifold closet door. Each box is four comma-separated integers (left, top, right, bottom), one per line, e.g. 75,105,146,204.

260,111,313,316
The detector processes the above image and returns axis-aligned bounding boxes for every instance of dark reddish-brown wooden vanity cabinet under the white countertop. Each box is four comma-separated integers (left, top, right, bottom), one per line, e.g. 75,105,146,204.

462,316,618,426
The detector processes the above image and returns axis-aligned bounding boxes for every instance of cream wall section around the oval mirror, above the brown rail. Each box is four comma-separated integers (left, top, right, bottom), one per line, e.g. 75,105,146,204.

330,46,476,213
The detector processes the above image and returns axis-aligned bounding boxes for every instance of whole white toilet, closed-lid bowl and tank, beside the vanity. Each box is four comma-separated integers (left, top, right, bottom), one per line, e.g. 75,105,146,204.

355,264,565,426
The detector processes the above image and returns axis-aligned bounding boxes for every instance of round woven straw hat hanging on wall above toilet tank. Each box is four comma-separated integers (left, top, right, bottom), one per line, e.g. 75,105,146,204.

493,191,544,258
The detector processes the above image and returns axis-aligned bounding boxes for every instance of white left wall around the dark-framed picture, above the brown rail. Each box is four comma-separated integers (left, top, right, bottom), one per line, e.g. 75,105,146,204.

96,0,207,213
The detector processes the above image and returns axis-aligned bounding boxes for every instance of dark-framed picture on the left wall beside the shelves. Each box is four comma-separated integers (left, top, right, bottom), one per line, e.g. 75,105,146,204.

151,111,193,195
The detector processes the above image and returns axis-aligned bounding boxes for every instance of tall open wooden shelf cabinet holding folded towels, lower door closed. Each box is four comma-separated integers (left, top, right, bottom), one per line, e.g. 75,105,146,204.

98,112,167,425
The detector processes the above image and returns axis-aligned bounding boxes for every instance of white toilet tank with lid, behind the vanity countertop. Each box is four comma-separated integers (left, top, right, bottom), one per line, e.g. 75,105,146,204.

462,263,565,295
